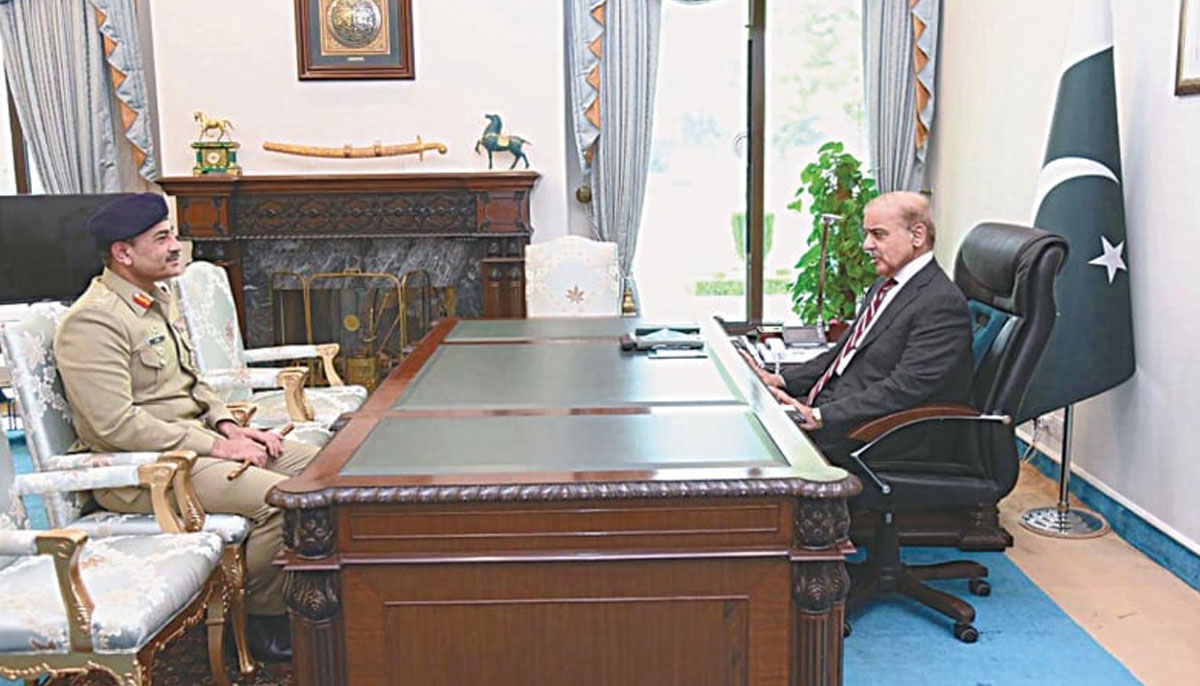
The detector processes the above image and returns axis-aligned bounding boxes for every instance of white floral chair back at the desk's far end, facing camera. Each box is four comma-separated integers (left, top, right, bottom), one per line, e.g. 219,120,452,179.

524,236,620,317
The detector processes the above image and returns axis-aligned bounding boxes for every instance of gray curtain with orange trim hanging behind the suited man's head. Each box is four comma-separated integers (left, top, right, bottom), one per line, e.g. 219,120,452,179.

863,0,941,192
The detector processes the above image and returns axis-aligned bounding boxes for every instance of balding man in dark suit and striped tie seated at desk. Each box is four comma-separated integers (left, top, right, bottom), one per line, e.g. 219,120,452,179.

756,192,971,464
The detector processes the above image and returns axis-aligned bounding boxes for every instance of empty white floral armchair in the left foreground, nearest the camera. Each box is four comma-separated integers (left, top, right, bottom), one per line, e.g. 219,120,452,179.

0,453,229,686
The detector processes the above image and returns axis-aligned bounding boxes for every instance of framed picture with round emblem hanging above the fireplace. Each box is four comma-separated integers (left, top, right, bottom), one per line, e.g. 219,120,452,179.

295,0,414,80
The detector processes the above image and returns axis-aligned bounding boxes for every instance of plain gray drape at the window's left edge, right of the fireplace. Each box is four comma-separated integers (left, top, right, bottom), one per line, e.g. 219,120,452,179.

592,0,662,305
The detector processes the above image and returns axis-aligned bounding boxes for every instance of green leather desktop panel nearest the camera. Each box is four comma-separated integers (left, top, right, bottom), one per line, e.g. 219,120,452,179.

342,407,787,476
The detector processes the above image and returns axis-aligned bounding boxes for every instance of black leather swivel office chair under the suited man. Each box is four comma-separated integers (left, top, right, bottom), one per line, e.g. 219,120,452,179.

846,223,1067,643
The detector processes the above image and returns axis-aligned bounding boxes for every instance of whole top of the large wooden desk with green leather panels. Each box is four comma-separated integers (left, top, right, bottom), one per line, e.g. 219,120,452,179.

304,318,846,486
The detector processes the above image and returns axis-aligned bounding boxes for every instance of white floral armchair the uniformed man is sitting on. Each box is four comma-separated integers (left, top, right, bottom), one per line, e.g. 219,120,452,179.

0,303,256,674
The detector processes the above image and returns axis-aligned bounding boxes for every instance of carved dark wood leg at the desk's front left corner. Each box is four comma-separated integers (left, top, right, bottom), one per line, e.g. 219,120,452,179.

283,507,346,686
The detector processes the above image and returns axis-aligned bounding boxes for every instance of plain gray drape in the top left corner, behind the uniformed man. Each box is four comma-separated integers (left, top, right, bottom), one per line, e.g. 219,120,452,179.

0,0,121,193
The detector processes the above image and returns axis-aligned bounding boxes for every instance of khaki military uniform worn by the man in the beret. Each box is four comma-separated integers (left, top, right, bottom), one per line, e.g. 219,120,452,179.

54,269,317,614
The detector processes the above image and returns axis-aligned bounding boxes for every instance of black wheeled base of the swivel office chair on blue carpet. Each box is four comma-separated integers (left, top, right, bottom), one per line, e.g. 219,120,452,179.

846,512,991,643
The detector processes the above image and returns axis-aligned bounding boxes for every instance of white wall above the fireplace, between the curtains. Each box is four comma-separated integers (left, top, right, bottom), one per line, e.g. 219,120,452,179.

151,0,568,241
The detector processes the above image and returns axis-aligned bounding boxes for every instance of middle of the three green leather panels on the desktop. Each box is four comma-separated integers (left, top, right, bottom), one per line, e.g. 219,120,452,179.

392,341,743,410
